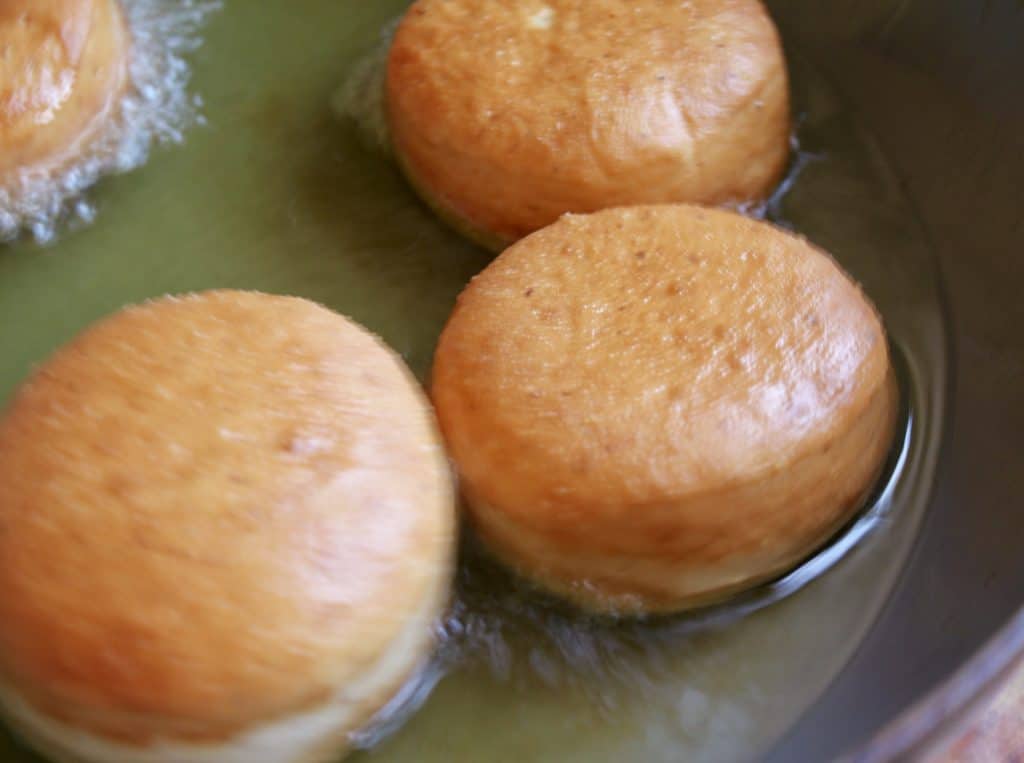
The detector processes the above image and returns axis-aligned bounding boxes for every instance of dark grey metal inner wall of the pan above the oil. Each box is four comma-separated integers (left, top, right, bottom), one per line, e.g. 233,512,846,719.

768,0,1024,761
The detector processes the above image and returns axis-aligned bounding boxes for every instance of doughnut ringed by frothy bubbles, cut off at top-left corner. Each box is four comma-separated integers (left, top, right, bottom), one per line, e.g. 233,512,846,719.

0,0,131,185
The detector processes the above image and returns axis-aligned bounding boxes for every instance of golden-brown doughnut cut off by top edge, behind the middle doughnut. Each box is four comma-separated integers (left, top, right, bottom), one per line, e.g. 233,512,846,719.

386,0,790,248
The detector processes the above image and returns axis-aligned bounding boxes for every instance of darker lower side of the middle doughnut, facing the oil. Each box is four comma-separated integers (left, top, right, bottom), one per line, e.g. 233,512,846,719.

466,364,898,616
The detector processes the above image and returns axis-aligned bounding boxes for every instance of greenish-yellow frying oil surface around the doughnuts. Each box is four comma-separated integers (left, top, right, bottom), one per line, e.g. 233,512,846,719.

0,0,946,763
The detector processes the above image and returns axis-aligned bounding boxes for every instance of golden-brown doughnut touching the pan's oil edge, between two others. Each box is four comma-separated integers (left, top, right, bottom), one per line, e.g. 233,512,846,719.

432,205,897,612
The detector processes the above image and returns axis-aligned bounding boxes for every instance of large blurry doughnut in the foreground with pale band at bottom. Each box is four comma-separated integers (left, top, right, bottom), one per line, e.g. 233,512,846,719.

0,292,456,763
